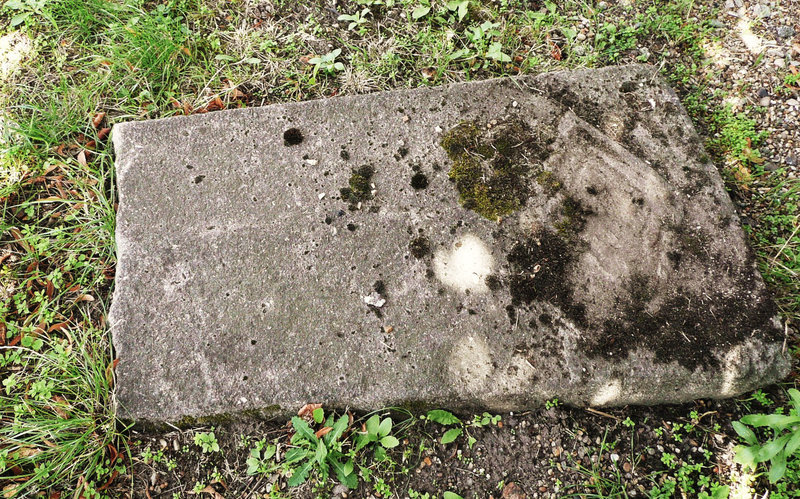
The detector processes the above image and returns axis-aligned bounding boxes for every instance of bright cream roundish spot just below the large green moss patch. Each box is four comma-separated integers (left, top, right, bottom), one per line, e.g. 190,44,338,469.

433,234,494,293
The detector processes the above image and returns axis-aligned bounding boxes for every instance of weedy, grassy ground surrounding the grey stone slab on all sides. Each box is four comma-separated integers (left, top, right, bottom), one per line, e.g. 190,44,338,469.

0,0,800,499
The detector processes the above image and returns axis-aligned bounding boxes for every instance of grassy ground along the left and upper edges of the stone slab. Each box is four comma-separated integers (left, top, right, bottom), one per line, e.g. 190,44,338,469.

0,0,800,497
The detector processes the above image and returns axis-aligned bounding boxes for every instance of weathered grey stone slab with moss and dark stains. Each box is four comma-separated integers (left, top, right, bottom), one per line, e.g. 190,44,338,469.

111,62,789,420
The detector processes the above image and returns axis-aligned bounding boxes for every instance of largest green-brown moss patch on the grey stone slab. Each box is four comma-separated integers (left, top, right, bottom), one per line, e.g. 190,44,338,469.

440,117,554,220
